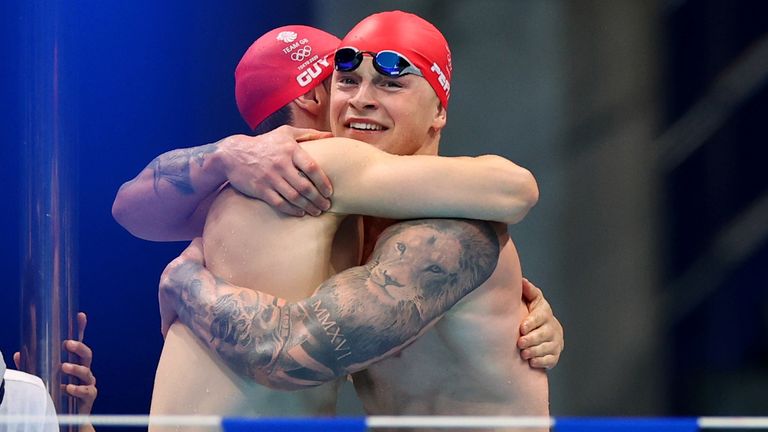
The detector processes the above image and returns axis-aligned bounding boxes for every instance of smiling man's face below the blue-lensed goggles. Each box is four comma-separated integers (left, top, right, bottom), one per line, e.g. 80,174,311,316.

330,56,446,155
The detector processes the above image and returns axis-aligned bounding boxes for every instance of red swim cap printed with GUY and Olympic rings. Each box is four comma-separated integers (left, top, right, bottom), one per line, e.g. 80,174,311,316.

235,25,339,129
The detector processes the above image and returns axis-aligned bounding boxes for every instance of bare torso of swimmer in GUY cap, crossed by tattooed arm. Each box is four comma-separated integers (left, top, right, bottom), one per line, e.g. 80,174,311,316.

151,188,358,426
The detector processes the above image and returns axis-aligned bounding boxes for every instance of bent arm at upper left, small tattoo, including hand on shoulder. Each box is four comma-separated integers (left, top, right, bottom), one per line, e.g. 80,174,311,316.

112,126,331,241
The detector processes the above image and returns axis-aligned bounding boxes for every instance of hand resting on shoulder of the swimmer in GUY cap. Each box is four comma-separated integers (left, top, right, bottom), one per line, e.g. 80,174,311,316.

219,126,333,216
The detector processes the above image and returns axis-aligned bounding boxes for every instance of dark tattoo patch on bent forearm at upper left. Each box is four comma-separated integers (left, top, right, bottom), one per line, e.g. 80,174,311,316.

149,143,218,195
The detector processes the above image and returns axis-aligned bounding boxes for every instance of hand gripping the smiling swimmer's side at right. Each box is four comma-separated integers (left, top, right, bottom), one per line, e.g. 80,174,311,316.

517,278,565,369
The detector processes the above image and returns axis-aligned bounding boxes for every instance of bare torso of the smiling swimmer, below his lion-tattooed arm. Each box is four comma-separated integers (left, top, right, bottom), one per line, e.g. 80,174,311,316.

354,234,549,430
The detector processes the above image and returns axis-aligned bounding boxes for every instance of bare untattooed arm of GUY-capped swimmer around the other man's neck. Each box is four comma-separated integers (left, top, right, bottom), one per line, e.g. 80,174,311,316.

302,138,539,224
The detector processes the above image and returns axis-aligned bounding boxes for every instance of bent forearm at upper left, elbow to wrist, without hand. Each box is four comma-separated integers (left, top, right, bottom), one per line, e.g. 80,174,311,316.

112,142,227,241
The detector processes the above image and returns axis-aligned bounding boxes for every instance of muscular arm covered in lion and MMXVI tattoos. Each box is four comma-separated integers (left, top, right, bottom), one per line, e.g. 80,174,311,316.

160,219,499,389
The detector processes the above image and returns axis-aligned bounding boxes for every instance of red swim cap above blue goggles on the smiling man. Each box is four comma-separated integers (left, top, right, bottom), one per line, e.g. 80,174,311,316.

339,11,453,109
